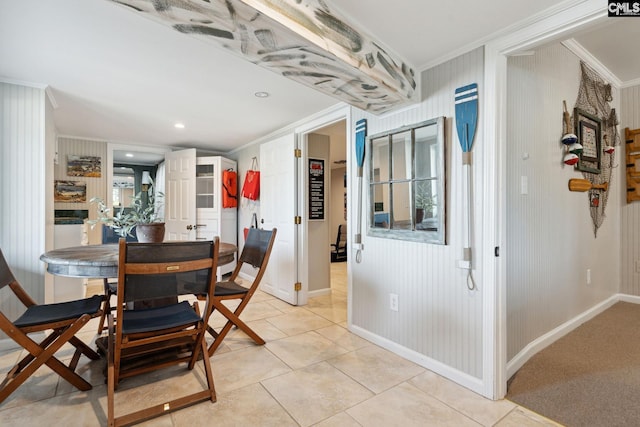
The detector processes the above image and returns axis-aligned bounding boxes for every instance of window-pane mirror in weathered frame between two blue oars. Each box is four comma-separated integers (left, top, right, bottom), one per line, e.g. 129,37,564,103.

367,117,446,244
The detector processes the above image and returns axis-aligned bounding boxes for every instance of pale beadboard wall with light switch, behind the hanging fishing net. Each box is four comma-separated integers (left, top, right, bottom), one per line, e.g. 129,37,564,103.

503,44,624,361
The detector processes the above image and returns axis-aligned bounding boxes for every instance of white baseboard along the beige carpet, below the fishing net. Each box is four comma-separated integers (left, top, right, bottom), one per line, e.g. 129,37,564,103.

507,294,640,378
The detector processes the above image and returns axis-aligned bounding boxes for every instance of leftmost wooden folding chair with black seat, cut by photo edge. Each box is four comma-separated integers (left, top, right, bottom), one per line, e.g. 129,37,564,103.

0,249,102,403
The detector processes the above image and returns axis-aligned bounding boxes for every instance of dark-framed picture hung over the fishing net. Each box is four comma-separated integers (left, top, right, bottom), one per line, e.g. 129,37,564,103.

573,108,602,173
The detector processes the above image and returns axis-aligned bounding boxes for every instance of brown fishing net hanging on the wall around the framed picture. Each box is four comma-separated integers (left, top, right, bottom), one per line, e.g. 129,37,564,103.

572,61,620,237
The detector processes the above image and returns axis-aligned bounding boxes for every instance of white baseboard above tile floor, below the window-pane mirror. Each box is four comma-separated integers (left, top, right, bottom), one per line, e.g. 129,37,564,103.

349,324,485,395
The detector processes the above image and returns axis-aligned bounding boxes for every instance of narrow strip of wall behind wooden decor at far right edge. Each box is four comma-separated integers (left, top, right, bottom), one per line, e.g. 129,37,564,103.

619,86,640,296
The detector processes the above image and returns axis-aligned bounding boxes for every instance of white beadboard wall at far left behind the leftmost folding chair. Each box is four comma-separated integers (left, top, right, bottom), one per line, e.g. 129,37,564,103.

0,82,51,326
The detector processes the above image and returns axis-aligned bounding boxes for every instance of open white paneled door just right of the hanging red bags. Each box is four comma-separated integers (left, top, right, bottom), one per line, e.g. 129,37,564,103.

259,133,298,305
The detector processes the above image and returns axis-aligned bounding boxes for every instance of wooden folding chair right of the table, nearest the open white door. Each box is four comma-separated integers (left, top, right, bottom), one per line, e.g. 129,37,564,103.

199,228,277,356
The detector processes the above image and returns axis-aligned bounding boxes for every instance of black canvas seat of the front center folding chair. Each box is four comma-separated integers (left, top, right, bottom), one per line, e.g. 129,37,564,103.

122,301,202,334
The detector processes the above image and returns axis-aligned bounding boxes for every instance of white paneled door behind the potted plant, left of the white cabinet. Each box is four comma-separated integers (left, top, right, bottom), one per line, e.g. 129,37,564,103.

164,148,196,240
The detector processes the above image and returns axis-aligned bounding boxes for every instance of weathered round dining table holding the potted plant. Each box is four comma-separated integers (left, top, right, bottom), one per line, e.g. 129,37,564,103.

40,242,238,279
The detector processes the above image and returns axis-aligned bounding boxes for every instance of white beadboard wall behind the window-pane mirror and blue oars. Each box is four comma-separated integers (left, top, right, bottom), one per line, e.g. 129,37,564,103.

348,49,484,385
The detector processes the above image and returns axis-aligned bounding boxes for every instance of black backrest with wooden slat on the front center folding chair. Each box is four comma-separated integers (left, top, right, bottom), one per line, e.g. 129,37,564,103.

120,241,217,303
